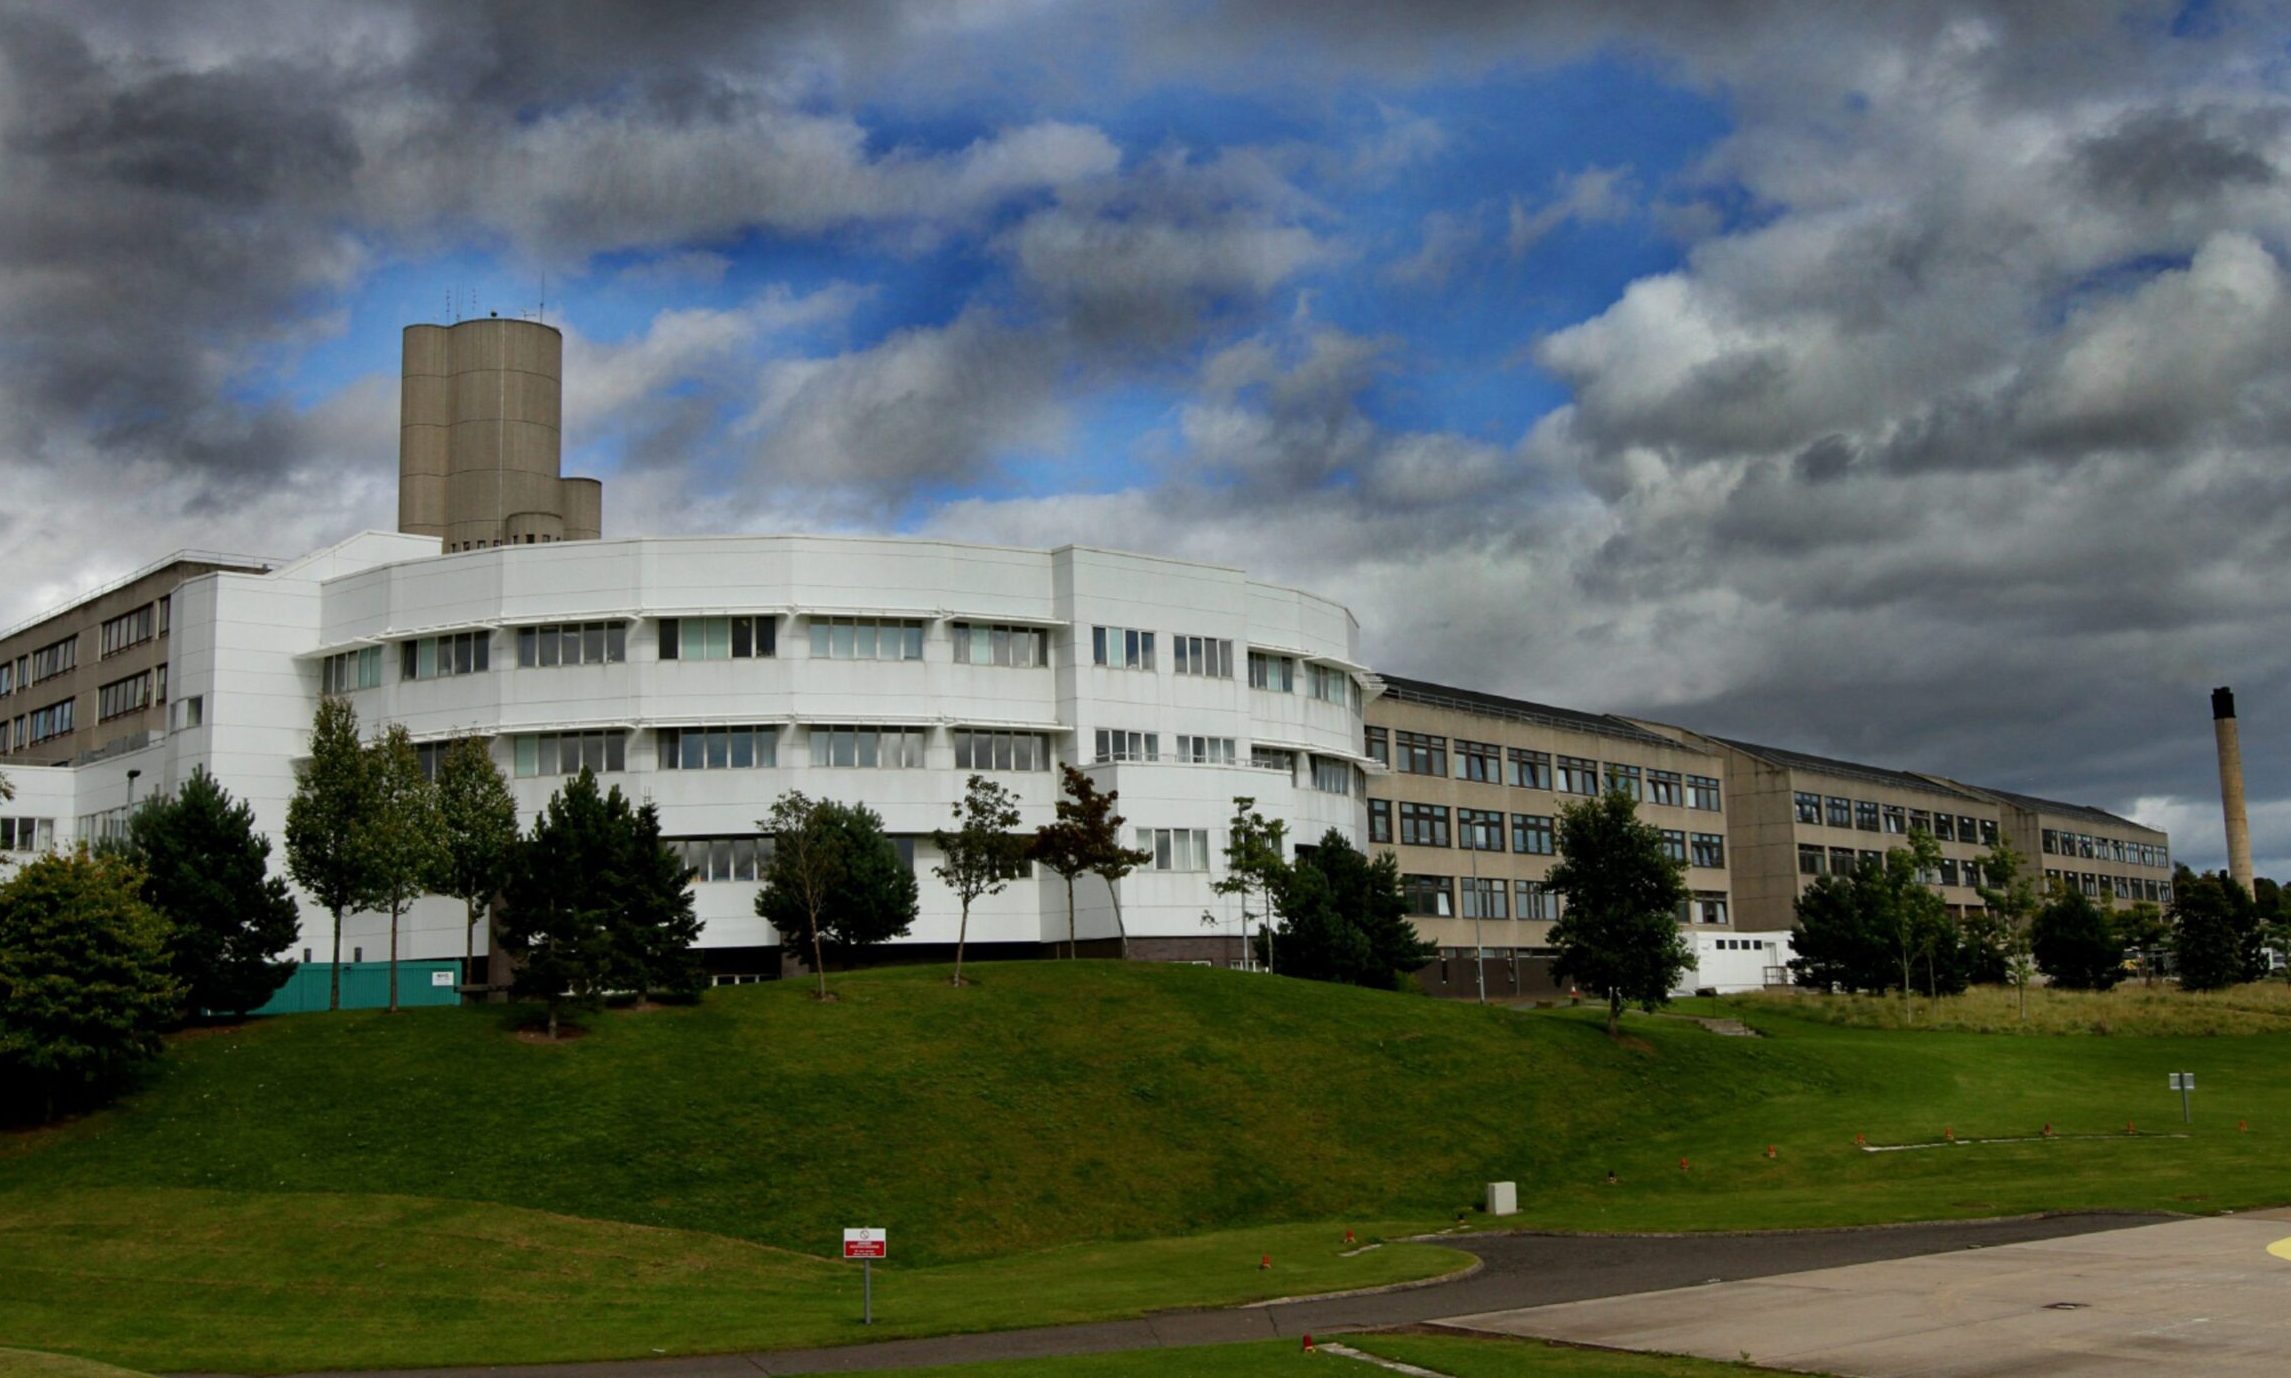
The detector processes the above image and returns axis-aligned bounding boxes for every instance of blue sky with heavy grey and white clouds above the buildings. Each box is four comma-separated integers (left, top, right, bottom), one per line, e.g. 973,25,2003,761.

0,0,2291,876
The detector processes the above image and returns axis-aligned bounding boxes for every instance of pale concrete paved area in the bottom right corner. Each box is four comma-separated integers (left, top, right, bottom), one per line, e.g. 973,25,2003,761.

1441,1211,2291,1378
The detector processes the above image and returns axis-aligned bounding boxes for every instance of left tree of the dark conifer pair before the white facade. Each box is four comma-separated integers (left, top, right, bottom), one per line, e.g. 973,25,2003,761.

497,768,612,1039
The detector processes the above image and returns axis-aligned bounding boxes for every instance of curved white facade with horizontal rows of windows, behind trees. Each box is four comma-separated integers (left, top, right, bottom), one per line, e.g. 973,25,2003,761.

134,532,1363,970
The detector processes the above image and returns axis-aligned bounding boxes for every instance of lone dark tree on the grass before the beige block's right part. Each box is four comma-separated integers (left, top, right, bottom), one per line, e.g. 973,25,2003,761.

1544,789,1695,1036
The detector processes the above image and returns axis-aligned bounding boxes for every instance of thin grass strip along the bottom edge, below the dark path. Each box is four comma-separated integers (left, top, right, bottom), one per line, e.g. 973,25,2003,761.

861,1334,1780,1378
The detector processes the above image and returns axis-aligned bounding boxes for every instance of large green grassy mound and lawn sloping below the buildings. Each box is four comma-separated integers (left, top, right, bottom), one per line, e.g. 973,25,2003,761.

0,963,2291,1371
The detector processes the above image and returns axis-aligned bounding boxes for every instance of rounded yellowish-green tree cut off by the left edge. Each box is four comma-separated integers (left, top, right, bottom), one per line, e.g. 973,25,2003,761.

0,848,181,1121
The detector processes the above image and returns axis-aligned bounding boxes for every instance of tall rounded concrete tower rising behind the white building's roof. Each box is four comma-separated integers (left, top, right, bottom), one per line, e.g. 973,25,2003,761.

399,319,605,550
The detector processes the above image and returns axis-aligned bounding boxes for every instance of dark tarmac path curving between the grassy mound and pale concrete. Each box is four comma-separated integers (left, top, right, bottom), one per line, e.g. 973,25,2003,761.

237,1215,2163,1378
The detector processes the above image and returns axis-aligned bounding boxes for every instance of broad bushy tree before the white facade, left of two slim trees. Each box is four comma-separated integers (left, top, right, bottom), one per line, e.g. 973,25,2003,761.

756,789,916,1000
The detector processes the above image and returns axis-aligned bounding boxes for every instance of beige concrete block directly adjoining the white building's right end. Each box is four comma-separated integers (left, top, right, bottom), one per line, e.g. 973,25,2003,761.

1365,676,1732,1000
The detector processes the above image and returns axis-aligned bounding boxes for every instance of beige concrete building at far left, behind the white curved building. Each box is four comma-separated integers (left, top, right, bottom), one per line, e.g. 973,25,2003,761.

0,550,270,766
